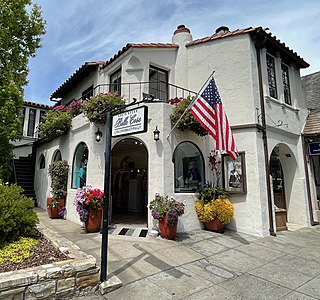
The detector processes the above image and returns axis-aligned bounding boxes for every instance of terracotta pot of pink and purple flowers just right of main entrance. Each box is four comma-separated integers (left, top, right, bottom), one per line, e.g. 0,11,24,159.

149,193,185,239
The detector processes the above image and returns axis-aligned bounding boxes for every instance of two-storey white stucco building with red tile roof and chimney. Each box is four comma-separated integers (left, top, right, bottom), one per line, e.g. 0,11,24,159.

35,25,317,235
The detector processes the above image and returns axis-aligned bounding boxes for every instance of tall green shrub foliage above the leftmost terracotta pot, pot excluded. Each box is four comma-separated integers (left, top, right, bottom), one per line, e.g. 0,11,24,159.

49,160,69,203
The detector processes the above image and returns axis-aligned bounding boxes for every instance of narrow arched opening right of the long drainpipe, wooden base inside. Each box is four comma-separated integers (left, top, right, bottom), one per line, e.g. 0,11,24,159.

270,146,288,231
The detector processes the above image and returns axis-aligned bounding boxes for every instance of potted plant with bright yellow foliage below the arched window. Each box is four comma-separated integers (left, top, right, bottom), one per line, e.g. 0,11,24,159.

195,187,234,232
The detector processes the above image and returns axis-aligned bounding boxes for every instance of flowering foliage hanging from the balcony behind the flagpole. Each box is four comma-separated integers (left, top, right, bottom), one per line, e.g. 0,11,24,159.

170,97,208,136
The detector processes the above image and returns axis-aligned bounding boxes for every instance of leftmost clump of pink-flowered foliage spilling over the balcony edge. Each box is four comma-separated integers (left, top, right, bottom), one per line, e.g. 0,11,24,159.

39,110,72,142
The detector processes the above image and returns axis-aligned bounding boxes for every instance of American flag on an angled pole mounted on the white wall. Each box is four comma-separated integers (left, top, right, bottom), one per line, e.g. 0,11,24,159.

190,79,239,160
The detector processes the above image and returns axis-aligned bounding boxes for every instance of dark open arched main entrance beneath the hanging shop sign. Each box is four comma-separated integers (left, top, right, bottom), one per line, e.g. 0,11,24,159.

111,138,148,227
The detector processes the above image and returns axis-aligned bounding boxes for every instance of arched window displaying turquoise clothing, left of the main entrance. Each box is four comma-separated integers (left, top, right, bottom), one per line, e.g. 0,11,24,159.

72,143,89,188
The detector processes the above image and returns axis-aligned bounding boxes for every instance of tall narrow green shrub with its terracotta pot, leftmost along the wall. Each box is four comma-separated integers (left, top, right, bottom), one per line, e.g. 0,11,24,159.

47,160,69,218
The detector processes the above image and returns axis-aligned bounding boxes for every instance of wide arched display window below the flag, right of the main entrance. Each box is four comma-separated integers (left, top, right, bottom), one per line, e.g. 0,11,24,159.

173,142,204,193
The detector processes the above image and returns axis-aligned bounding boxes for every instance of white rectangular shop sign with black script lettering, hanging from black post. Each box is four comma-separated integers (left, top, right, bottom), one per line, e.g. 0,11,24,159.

112,106,148,137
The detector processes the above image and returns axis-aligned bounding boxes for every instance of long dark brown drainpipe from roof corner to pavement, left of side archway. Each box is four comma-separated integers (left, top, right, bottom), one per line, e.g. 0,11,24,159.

255,36,276,236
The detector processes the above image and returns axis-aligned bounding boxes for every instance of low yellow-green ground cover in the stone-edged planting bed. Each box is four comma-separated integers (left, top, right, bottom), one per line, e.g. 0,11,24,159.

0,237,39,264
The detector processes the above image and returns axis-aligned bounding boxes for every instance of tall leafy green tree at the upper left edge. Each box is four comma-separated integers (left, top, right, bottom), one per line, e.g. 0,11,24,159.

0,0,45,181
